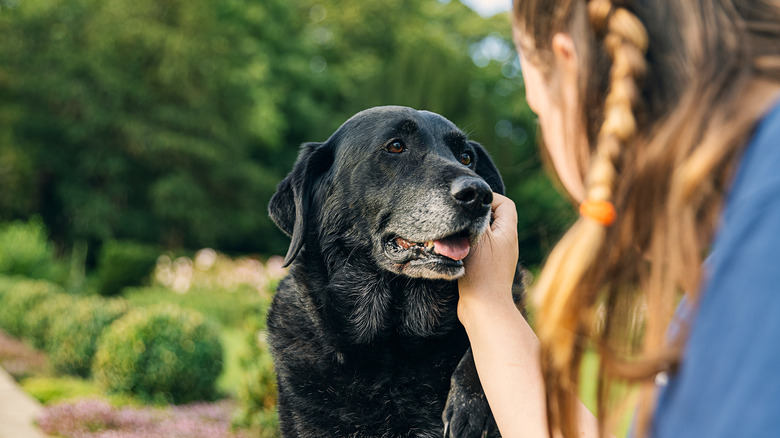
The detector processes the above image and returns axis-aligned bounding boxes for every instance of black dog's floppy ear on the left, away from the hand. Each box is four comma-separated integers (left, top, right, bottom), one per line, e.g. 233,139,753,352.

268,143,333,266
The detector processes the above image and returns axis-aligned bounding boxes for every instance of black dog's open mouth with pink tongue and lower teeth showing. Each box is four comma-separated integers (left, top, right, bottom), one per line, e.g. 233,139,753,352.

385,231,471,267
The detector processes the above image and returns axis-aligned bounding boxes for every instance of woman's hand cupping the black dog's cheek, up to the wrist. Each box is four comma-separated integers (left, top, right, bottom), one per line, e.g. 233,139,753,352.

458,193,518,325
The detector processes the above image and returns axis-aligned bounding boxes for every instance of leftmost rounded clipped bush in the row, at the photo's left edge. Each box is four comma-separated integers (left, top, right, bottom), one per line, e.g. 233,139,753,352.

0,280,62,338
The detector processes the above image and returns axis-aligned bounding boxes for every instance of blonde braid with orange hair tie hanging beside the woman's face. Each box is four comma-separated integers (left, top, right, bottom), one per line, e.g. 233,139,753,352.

536,0,648,436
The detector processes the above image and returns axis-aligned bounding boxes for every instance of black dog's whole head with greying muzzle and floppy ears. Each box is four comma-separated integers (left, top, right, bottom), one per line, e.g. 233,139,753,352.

269,106,504,280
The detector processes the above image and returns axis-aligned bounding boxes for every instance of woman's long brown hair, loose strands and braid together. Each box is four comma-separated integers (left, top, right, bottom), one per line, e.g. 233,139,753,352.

513,0,780,436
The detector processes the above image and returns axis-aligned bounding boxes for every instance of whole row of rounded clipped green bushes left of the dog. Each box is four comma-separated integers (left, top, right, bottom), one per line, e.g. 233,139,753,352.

0,275,230,404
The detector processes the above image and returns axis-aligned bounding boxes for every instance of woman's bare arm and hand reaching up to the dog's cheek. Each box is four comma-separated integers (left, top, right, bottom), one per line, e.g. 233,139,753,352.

458,194,599,438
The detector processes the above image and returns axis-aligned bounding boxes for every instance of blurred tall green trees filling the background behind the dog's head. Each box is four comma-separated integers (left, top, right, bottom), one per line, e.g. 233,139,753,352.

0,0,573,271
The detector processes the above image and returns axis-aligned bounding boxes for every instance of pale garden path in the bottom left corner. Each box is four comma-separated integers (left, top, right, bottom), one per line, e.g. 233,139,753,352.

0,368,48,438
